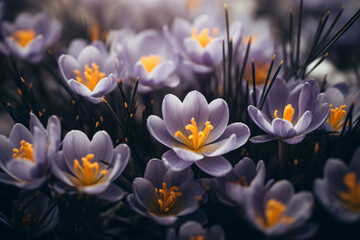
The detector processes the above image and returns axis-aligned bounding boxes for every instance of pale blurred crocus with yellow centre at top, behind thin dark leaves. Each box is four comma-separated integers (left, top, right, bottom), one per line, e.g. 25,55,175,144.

169,15,242,73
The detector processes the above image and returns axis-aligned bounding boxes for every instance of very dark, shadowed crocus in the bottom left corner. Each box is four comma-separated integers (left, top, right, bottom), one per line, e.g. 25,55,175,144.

12,191,59,238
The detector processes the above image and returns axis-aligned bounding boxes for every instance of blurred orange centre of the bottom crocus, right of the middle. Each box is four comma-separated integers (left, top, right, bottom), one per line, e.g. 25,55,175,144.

258,198,295,228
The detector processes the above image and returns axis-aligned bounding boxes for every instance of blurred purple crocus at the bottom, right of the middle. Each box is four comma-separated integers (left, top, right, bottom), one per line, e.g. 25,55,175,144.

244,180,316,239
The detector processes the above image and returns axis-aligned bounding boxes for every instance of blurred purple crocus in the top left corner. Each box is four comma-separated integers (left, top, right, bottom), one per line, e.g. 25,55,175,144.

1,12,61,64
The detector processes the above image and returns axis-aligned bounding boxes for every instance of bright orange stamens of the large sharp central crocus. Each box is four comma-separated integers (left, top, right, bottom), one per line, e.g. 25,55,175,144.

175,118,214,150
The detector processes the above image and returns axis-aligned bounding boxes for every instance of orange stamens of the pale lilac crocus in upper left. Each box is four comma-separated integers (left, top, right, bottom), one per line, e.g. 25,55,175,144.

74,62,106,91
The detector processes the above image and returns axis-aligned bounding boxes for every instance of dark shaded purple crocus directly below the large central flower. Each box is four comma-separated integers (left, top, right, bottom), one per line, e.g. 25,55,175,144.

127,159,205,225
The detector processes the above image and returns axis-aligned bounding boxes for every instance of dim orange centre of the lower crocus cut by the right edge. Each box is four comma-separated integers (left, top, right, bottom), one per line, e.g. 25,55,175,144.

339,172,360,211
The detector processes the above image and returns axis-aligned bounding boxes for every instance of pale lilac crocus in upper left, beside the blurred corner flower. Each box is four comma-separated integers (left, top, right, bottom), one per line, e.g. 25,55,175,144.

58,40,123,103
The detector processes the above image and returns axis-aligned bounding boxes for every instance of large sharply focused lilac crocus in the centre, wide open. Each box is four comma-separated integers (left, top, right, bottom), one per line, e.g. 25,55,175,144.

147,91,250,176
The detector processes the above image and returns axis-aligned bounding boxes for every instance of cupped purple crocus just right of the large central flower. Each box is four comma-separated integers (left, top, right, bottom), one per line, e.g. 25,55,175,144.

248,78,330,144
